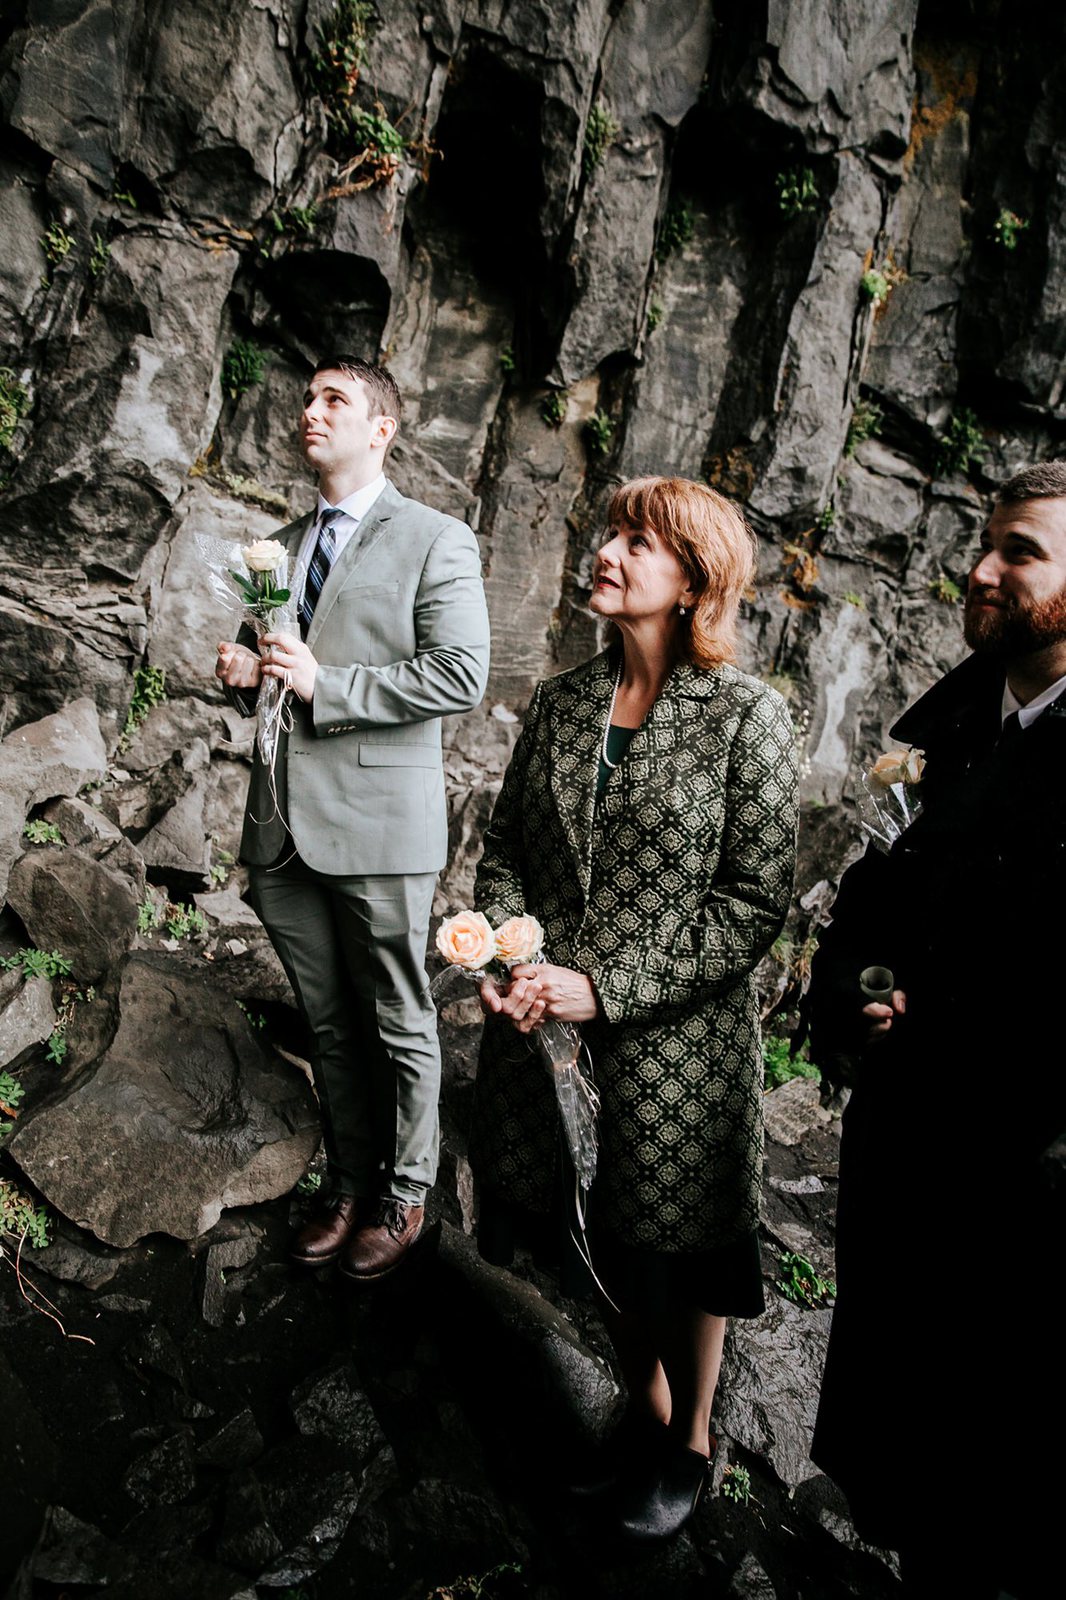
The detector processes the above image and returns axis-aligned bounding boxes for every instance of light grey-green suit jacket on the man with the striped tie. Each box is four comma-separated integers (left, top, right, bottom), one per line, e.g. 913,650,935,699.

234,483,488,875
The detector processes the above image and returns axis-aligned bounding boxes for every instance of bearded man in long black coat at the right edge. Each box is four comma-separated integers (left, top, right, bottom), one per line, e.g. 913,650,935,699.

810,461,1066,1600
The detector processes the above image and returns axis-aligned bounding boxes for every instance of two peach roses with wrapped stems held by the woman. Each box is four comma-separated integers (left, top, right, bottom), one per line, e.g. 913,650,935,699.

429,910,600,1190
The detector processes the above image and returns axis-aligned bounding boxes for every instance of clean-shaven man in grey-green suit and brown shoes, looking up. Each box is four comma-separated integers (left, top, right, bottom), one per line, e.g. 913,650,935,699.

216,355,488,1280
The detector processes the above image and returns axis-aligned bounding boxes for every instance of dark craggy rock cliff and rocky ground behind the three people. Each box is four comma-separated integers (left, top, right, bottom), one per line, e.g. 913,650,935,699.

0,0,1066,1597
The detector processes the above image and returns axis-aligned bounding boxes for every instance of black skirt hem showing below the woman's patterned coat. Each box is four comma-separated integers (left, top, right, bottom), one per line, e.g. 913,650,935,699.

477,1184,765,1317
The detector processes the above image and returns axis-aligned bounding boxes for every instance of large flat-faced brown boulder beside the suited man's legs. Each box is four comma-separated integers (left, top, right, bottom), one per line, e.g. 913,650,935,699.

8,952,319,1246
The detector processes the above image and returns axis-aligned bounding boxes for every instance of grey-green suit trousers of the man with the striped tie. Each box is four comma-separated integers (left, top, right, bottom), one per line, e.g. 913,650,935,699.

250,845,440,1205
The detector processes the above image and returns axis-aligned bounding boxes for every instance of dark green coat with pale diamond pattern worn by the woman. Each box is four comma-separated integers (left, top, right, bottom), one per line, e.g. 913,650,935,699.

471,653,795,1251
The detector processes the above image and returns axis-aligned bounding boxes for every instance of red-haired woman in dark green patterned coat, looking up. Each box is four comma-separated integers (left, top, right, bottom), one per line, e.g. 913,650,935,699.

471,478,795,1538
